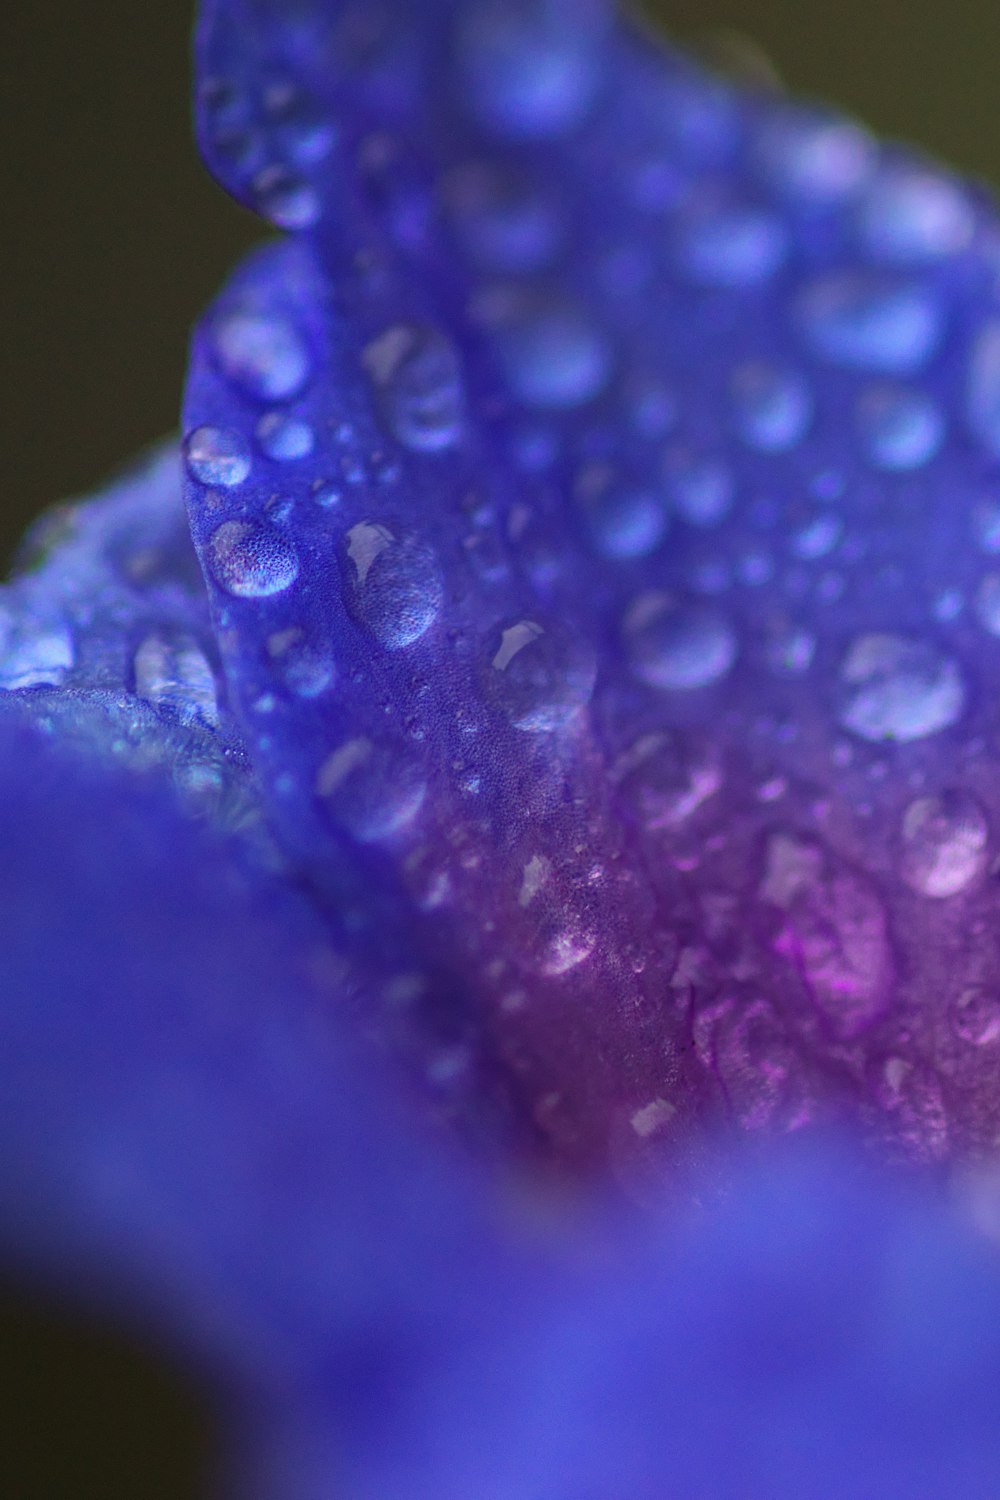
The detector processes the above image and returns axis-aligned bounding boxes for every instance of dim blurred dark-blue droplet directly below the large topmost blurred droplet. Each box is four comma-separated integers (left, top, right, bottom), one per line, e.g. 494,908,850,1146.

442,162,564,273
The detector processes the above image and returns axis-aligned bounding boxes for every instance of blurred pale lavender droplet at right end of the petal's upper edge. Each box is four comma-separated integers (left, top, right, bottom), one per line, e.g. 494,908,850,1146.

859,165,976,266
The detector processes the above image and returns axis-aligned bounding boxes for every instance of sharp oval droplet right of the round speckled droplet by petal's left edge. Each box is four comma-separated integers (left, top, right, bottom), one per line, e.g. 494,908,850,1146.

342,521,444,651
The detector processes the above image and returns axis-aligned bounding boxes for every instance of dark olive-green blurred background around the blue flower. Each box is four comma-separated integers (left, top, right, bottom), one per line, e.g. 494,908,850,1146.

0,0,1000,1500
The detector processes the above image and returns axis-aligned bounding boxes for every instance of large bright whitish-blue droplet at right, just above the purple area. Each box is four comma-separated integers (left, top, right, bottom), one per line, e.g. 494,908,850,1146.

838,635,966,744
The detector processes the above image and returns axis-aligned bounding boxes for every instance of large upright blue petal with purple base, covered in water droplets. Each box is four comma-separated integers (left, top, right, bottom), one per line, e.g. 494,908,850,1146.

184,0,1000,1181
